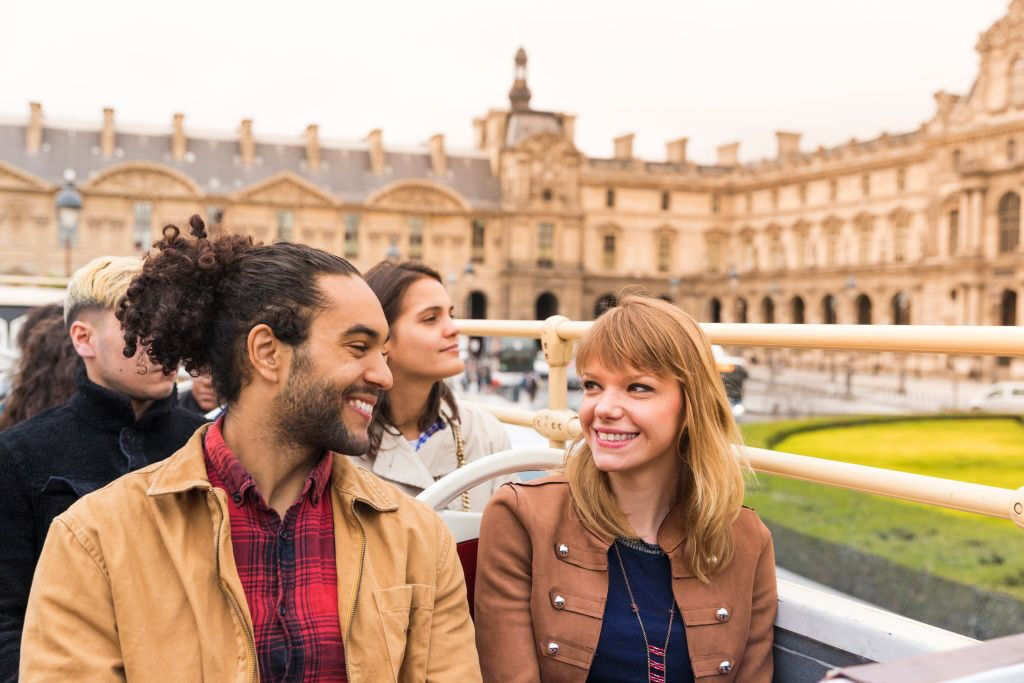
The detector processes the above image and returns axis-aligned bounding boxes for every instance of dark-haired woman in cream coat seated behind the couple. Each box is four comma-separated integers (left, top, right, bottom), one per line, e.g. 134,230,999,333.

362,261,510,512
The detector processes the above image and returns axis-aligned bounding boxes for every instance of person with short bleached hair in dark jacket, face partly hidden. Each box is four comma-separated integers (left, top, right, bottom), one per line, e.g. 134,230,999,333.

0,257,204,682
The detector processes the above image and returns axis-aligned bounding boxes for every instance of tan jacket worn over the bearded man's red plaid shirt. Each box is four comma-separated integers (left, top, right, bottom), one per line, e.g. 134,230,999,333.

22,427,480,683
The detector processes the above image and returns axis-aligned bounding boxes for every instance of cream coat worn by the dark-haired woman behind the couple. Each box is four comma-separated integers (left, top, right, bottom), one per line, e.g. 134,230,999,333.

359,404,511,512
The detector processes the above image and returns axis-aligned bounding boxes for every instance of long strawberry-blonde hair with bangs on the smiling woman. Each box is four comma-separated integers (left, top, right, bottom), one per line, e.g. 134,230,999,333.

565,296,744,582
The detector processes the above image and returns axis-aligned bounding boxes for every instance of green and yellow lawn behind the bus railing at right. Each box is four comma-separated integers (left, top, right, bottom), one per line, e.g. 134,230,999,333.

743,419,1024,599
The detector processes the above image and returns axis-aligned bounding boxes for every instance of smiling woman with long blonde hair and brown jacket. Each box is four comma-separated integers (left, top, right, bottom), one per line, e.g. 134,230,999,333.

475,296,776,683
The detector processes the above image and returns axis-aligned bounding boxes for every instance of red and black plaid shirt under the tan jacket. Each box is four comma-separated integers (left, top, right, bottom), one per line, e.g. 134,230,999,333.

204,420,346,683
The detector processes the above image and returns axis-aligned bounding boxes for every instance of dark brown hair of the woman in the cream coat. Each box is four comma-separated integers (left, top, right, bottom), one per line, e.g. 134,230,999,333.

366,261,459,458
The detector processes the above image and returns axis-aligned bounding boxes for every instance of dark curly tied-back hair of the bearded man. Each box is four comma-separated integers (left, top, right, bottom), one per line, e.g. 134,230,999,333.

117,215,360,403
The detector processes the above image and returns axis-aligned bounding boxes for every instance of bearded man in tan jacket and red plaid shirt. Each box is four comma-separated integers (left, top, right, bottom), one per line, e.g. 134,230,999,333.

22,216,480,682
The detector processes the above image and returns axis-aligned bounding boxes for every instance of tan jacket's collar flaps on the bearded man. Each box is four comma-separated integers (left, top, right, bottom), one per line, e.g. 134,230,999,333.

146,424,398,512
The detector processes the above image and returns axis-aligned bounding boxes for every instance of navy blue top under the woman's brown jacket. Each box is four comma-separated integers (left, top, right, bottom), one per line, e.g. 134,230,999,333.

587,540,693,683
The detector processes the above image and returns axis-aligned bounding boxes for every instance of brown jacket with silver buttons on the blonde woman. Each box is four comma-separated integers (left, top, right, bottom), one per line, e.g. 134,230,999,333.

475,475,777,683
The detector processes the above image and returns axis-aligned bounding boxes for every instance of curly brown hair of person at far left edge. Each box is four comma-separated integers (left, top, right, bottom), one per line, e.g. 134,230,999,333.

0,304,83,429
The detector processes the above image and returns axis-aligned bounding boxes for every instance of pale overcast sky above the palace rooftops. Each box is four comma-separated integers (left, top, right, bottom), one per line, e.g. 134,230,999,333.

0,0,1009,163
